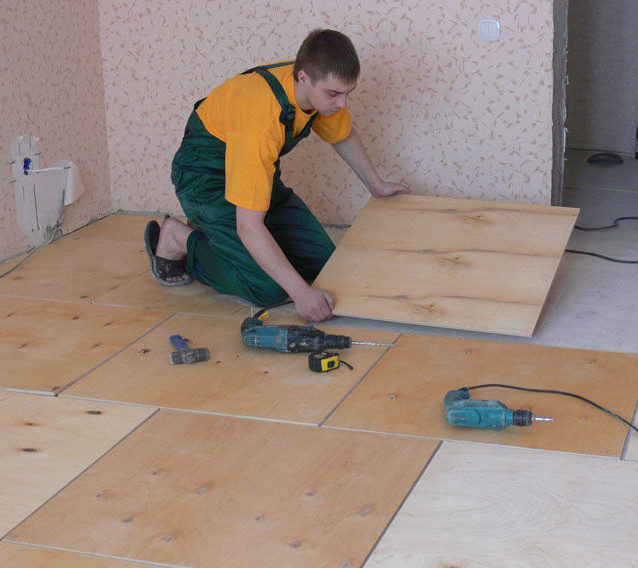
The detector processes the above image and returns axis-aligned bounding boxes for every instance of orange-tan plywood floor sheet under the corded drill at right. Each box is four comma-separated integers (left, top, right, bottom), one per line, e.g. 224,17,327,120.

327,334,638,457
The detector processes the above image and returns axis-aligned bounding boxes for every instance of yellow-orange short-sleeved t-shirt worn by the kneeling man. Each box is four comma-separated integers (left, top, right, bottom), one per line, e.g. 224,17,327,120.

197,64,352,211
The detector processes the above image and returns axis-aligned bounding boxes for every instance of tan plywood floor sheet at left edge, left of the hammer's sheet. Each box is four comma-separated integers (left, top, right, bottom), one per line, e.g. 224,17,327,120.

0,296,170,393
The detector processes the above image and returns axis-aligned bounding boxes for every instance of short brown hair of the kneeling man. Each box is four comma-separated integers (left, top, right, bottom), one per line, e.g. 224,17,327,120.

294,29,361,84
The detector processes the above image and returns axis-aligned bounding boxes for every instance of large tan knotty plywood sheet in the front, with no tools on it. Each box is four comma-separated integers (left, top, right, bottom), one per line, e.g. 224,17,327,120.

8,411,436,568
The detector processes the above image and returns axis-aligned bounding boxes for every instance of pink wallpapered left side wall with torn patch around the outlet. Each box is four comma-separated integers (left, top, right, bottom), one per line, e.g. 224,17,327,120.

0,0,111,260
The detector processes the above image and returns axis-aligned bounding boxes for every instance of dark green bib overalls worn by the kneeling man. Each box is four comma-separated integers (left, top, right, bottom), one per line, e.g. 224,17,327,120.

171,63,334,306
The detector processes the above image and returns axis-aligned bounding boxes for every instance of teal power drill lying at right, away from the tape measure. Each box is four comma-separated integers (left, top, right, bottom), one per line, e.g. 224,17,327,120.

443,387,554,429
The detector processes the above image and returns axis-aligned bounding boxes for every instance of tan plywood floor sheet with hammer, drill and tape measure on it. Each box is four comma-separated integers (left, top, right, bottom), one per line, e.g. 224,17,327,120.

64,311,397,424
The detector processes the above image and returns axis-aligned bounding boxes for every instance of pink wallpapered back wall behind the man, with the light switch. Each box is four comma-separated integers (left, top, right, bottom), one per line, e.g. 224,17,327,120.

99,0,553,223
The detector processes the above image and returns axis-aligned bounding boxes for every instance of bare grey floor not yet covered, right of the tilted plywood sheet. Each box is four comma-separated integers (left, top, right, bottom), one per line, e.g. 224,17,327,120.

322,166,638,353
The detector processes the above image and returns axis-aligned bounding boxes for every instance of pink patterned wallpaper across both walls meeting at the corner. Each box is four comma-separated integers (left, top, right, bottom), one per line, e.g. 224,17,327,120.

0,0,553,259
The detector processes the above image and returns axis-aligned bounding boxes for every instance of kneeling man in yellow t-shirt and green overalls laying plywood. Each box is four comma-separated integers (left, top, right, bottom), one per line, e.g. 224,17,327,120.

145,30,410,321
